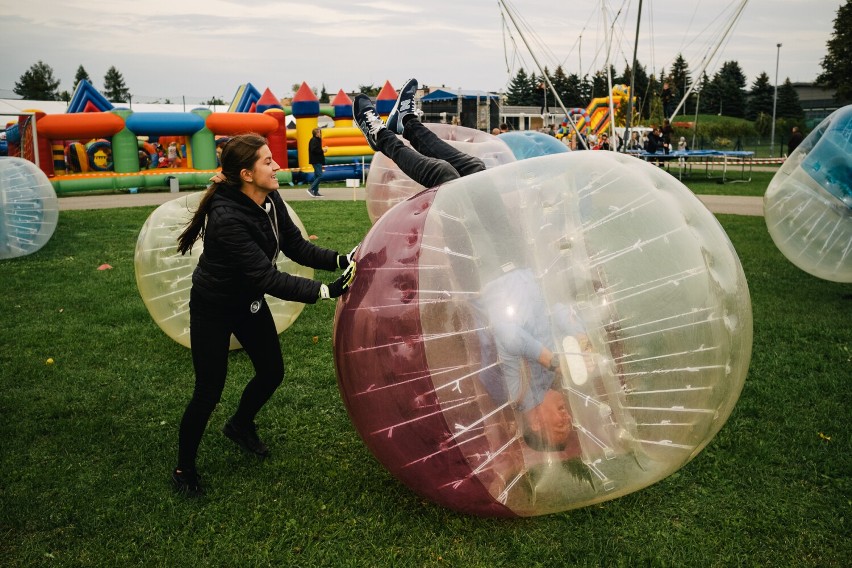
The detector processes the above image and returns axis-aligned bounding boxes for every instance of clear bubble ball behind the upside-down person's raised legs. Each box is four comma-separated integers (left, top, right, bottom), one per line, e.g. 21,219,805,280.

365,123,515,223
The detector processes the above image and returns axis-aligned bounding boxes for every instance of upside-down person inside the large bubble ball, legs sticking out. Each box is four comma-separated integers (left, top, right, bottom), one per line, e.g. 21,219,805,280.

352,79,580,450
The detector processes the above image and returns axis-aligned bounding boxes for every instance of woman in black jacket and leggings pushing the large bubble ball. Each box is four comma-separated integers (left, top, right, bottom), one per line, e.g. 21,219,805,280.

172,134,357,497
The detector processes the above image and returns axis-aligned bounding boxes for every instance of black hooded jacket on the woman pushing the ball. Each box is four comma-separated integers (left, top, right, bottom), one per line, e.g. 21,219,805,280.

192,186,338,305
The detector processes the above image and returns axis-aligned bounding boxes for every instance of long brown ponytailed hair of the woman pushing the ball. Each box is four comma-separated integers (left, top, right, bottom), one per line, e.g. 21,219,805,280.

178,133,267,254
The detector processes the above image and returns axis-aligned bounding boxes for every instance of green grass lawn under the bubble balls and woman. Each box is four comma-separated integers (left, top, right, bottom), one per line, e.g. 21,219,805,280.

0,197,852,567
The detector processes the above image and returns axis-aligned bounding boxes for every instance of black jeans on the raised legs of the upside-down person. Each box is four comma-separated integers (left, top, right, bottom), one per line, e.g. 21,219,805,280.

376,119,485,188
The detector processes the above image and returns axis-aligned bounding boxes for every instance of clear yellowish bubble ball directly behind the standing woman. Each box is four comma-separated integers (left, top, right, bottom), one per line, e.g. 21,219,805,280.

134,191,314,349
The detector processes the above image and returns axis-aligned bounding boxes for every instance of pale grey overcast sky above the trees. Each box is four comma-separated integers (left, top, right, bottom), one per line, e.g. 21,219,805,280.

0,0,845,102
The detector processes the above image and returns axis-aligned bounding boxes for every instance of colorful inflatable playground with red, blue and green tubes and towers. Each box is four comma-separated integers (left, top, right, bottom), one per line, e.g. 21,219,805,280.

0,81,412,195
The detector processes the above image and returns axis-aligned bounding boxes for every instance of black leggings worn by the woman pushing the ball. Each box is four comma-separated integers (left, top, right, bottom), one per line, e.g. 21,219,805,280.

178,290,284,470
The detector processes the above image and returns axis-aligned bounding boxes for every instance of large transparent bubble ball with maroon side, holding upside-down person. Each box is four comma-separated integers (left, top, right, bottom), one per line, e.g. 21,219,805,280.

334,152,752,517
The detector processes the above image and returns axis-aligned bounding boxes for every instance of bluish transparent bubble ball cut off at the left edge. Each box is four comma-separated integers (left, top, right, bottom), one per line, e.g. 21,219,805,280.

0,156,59,259
